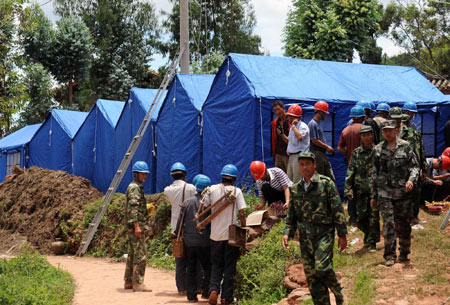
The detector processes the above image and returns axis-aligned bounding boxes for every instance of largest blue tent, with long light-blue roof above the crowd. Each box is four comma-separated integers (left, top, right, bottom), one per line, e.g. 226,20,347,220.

203,54,444,190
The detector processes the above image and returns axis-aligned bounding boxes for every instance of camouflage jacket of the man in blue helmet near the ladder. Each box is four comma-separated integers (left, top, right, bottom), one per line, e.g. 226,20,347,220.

125,180,148,230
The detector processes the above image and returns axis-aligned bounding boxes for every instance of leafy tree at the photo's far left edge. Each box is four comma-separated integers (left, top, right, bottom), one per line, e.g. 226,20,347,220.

0,0,27,136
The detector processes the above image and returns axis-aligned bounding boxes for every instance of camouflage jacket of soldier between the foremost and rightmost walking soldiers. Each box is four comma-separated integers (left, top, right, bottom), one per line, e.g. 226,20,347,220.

344,145,373,197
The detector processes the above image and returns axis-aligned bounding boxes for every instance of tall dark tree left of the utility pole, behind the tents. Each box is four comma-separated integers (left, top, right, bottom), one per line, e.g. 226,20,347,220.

55,0,159,100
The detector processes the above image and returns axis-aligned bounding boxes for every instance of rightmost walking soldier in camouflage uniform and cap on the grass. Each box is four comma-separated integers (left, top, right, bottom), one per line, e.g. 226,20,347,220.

370,121,419,266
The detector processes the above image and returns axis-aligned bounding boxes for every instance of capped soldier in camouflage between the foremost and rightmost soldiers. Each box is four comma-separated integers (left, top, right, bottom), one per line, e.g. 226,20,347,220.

344,126,380,252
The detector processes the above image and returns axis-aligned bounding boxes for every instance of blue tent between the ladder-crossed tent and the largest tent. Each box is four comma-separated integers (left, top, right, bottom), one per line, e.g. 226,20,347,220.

156,74,214,192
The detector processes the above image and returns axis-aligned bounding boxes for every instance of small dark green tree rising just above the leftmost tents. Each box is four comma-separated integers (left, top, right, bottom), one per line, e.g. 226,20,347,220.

20,63,55,127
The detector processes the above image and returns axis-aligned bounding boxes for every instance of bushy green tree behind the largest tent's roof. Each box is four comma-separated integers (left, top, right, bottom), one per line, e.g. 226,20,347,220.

283,0,382,63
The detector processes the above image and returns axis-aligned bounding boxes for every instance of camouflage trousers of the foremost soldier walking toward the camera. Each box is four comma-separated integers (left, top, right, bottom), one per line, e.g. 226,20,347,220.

300,229,344,305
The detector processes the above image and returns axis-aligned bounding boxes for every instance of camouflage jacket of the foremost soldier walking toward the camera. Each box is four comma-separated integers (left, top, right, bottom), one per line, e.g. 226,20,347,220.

285,173,347,238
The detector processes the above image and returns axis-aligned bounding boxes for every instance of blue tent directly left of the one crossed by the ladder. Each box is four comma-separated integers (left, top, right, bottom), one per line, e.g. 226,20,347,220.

73,99,125,192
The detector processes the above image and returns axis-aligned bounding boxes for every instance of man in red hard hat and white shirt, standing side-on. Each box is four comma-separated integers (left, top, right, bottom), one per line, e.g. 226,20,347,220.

286,104,309,183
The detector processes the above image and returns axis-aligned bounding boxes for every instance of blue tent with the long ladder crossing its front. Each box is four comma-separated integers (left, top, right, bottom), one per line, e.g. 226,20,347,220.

114,88,167,193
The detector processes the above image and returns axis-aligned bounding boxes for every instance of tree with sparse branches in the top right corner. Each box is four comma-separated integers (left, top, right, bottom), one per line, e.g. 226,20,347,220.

385,0,450,75
